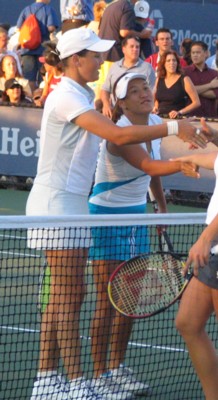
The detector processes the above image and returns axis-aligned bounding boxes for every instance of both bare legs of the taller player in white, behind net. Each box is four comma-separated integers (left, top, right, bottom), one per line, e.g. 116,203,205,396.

40,249,86,380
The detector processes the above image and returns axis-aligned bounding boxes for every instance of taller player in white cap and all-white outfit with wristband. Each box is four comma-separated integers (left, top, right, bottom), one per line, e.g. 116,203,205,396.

26,28,215,400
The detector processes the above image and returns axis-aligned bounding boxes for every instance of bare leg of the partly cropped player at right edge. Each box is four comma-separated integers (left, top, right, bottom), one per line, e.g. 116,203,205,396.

176,277,218,400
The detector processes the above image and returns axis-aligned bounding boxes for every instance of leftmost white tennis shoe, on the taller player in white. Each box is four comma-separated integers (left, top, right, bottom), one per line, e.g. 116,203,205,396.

30,374,69,400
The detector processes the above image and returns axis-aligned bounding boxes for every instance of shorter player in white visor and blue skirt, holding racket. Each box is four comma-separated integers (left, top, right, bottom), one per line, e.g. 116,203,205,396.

89,72,201,399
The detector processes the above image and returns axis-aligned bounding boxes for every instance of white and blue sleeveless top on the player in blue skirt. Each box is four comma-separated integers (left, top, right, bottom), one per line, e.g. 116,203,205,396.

89,114,162,208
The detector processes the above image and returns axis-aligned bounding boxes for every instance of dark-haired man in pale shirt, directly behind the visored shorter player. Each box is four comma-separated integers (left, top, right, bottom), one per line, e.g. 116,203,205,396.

101,34,155,118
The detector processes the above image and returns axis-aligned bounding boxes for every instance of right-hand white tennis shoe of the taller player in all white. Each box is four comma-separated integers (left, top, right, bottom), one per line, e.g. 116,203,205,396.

67,377,103,400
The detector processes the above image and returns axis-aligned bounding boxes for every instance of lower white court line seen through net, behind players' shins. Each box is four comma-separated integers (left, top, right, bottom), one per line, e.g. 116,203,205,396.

0,325,188,353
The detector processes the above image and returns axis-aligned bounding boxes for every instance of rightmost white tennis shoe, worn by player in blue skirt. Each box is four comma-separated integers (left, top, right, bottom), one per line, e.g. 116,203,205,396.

111,364,150,396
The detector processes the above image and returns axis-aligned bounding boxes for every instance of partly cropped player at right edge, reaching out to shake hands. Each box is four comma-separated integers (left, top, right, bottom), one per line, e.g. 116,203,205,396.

176,152,218,400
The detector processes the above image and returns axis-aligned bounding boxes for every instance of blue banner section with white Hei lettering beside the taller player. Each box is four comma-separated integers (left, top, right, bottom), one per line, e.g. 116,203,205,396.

0,106,42,177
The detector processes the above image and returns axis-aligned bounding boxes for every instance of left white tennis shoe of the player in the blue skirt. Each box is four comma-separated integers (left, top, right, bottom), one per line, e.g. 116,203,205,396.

92,371,134,400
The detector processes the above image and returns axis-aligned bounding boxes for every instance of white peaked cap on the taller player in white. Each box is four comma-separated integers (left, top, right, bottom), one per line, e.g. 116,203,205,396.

57,27,115,60
